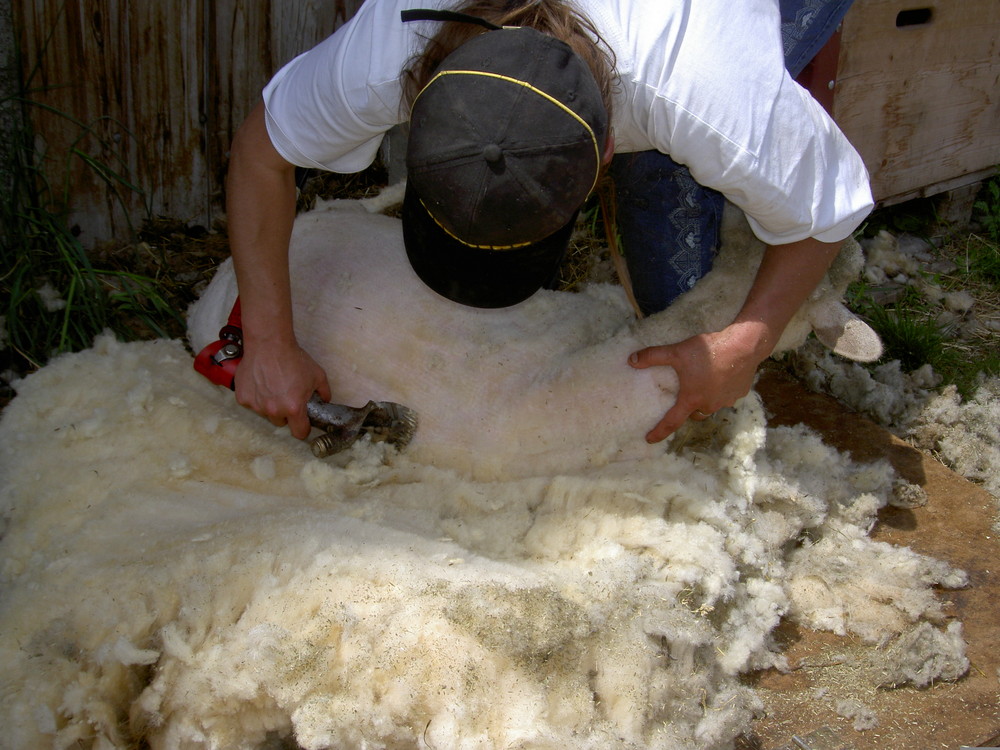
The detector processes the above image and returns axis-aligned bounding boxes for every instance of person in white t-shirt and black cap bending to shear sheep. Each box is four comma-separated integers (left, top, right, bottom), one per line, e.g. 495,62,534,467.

228,0,872,442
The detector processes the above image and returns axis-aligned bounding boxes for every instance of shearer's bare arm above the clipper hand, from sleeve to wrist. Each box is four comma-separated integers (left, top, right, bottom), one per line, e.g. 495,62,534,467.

226,104,295,347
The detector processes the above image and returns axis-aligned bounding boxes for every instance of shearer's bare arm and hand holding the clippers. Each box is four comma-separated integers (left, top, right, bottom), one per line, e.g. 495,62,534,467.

226,103,330,438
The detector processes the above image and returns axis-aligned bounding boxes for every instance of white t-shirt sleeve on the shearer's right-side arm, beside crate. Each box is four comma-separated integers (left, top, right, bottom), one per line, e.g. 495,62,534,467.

604,0,873,244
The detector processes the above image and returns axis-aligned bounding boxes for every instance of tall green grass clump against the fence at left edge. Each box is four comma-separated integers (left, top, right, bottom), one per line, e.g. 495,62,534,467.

0,42,180,382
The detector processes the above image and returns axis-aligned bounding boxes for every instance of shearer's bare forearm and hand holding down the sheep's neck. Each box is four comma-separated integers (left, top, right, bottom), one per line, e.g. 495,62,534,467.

629,239,841,443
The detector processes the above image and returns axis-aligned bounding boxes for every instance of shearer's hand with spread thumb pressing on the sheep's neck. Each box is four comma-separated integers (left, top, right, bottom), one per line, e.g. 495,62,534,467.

629,324,767,443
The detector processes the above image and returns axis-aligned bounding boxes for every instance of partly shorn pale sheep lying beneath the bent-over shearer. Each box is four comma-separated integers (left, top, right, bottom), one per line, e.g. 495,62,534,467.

189,198,881,478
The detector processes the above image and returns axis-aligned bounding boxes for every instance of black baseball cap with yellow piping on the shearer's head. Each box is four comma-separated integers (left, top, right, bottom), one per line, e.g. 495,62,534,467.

402,22,608,307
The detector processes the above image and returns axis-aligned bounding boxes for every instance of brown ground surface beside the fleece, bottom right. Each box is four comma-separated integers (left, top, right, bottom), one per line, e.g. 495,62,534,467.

737,370,1000,750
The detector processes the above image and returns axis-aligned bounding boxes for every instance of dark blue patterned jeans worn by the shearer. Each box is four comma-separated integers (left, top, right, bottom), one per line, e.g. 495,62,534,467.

610,0,853,315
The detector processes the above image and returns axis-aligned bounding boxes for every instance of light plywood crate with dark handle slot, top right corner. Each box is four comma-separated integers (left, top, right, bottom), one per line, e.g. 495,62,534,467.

832,0,1000,205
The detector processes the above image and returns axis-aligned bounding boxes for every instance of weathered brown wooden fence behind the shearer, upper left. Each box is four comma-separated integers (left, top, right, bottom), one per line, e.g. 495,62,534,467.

13,0,361,244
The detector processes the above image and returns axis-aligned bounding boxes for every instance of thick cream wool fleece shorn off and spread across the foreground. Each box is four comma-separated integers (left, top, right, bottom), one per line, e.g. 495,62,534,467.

0,337,961,750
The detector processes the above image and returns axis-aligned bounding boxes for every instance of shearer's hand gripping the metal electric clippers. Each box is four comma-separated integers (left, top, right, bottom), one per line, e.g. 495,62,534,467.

236,342,331,440
